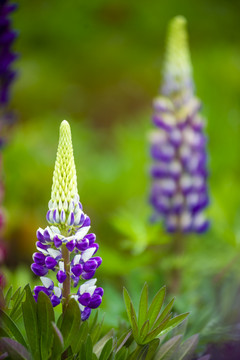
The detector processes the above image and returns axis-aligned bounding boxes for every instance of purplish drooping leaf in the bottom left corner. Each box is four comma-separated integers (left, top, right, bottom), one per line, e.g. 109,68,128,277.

0,337,31,360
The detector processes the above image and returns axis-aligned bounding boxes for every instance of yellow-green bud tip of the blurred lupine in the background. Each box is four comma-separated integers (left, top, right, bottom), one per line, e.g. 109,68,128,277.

163,16,192,89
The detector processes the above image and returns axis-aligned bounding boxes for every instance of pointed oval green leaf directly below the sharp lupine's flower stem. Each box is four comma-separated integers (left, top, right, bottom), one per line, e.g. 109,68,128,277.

61,298,81,350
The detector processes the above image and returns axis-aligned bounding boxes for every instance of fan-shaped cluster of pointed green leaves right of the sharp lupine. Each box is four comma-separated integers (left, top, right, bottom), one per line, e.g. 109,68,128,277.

123,283,188,346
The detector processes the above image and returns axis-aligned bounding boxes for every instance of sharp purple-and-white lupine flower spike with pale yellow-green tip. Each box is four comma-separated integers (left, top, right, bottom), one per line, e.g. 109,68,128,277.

31,120,103,320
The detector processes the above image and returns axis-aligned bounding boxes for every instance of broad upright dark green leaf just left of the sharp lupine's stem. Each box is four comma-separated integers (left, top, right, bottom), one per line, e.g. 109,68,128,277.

37,291,54,359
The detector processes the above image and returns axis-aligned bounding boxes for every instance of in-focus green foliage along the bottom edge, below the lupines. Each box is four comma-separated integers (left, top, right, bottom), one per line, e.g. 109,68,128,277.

0,284,206,360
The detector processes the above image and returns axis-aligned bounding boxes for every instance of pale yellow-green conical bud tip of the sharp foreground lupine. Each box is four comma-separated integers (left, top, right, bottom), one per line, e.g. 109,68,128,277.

49,120,78,211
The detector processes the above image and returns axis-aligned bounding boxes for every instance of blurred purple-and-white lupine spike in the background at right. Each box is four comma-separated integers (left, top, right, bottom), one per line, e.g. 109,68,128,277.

150,16,209,233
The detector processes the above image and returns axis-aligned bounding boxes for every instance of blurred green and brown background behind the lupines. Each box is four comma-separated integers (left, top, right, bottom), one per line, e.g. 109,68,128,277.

3,0,240,338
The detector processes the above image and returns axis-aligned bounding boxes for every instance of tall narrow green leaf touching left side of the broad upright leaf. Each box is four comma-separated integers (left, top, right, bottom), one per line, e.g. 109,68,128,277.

22,285,41,360
